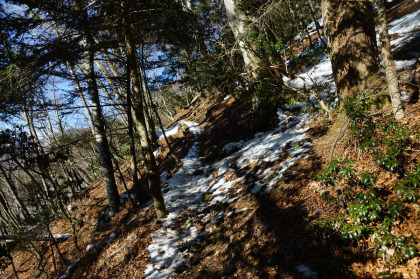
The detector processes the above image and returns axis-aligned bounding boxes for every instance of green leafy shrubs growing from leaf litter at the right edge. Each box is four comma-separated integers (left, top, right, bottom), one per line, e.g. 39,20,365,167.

309,93,420,272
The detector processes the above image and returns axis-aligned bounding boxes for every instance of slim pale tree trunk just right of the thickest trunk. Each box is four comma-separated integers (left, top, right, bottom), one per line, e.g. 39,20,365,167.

378,0,405,120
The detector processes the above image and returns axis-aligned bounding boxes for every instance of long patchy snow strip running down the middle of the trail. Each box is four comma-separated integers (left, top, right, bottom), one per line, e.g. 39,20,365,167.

145,106,310,278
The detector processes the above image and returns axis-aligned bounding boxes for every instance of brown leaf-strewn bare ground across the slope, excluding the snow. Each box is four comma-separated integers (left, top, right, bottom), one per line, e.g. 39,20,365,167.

0,1,420,278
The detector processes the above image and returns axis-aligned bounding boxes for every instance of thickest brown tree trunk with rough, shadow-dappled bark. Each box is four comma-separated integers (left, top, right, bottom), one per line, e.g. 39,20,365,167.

321,0,379,106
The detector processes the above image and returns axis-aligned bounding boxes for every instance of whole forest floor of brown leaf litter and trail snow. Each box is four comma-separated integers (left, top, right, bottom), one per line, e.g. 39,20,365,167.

0,1,420,279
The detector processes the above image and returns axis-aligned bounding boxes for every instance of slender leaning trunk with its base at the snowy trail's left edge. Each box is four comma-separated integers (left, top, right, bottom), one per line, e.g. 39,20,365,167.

122,1,168,218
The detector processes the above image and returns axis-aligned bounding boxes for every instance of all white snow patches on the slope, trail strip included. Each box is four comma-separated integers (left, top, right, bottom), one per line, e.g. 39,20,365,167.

145,8,420,279
